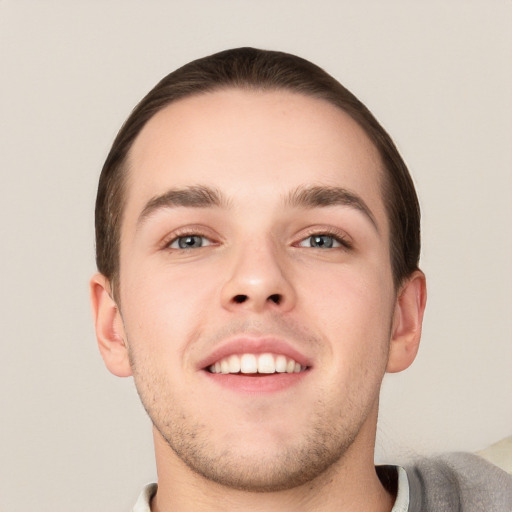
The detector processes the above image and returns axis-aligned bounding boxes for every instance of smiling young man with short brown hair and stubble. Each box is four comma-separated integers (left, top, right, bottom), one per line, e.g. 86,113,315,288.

91,48,506,512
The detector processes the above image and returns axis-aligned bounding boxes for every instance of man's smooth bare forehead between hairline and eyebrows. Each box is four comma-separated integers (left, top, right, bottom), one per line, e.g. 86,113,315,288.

125,89,382,222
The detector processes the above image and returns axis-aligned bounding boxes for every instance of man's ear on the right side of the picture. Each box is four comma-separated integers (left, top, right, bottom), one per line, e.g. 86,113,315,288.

386,270,427,373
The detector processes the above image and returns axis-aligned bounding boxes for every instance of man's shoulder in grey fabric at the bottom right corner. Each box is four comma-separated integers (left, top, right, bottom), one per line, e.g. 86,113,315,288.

406,453,512,512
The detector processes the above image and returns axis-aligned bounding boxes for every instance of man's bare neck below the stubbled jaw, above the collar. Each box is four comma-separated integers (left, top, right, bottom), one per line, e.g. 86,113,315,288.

151,416,395,512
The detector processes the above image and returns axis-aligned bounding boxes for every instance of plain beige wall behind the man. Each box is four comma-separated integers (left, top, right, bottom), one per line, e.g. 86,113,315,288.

0,0,512,512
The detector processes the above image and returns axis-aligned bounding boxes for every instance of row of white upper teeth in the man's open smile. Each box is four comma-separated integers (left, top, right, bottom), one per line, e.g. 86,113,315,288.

209,354,306,373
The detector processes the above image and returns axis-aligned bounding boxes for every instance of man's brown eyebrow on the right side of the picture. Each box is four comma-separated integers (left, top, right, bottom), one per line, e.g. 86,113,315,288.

285,186,379,232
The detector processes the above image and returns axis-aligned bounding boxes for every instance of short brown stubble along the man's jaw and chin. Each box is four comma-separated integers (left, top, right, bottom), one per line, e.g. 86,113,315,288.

136,372,365,492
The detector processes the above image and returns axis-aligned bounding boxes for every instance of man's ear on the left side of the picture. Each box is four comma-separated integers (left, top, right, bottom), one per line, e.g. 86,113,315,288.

90,274,132,377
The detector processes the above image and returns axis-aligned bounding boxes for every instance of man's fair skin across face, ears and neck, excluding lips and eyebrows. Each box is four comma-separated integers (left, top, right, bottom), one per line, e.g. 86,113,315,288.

91,90,425,511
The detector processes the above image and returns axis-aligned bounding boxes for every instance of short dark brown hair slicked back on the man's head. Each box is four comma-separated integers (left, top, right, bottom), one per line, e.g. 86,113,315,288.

95,48,420,287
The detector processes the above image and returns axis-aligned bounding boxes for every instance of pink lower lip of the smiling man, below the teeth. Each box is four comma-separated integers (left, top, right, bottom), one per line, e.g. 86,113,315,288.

204,370,309,393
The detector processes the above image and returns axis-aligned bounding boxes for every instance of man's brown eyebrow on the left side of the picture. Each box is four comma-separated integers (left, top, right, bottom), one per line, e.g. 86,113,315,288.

137,185,229,225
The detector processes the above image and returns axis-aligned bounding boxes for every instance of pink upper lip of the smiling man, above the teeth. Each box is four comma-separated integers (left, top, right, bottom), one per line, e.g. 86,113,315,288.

198,336,312,370
